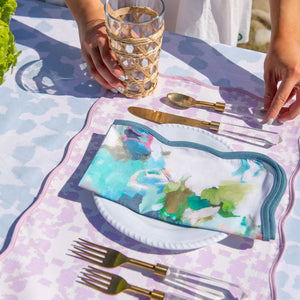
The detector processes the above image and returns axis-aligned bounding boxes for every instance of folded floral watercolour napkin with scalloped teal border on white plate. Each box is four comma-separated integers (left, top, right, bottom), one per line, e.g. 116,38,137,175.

79,120,286,240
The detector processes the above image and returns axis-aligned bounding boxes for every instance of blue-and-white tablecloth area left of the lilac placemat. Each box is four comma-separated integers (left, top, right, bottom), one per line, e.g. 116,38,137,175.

0,0,105,253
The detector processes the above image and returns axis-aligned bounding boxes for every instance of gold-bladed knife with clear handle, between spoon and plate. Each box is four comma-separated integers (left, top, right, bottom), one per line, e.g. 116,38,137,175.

128,106,282,148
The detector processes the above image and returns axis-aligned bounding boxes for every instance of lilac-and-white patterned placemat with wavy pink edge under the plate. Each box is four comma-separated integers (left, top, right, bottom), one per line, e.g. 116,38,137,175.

0,76,300,300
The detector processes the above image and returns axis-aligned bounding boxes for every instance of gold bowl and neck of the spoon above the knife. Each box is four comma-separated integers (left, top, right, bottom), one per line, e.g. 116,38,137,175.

167,93,225,112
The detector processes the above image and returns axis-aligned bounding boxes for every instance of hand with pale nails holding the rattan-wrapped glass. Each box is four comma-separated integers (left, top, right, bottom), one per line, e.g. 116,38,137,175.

79,19,125,93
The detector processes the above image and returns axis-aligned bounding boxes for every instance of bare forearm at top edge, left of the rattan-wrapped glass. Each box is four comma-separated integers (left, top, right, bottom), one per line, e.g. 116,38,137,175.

65,0,105,26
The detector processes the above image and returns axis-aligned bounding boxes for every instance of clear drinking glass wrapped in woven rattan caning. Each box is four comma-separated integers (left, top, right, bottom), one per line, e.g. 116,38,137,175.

105,0,165,98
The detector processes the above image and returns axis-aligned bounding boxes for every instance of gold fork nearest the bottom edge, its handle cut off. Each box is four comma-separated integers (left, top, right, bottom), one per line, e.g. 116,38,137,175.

79,266,189,300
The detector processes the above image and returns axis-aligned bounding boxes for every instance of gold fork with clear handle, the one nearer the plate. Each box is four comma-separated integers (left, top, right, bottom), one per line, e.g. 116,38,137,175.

71,238,247,299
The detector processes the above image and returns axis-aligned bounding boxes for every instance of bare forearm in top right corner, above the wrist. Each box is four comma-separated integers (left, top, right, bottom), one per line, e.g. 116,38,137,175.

270,0,300,42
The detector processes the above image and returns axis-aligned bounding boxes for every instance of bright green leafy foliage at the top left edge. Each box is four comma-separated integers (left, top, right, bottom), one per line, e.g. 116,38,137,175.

0,0,20,85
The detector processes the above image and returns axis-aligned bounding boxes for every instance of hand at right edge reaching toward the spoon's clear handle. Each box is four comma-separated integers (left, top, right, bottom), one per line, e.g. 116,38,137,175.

264,40,300,124
